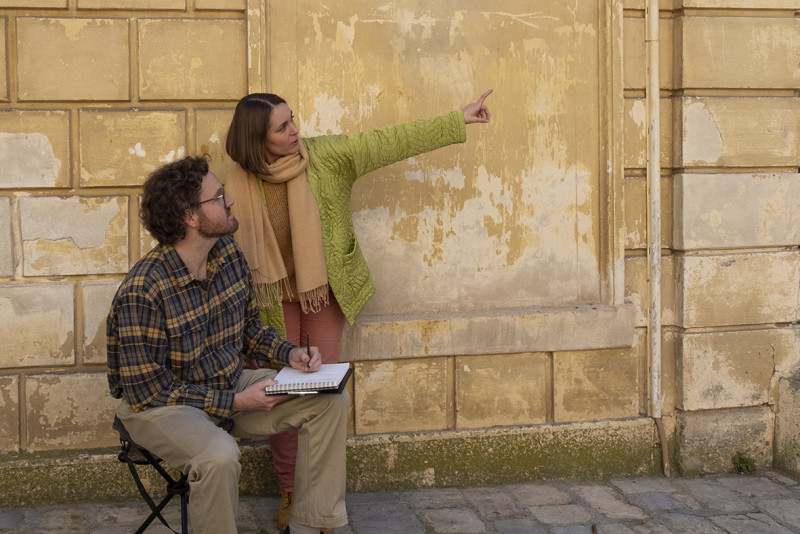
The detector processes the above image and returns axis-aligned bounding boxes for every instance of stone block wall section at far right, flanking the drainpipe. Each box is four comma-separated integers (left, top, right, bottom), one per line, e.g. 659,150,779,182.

626,0,800,474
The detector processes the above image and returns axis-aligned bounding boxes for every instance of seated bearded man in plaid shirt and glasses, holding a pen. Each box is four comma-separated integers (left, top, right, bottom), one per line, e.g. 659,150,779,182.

107,157,350,534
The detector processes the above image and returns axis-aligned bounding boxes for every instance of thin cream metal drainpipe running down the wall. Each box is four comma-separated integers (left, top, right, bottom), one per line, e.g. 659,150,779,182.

645,0,671,477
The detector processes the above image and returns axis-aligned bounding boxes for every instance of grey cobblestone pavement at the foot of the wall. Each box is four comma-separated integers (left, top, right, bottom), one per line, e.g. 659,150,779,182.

0,470,800,534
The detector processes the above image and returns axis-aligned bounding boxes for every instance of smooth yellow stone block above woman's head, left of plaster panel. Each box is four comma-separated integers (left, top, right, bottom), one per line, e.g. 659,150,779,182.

139,19,247,100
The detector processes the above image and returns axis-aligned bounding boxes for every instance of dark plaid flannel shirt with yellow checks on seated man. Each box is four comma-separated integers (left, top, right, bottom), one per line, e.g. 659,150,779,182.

106,236,294,417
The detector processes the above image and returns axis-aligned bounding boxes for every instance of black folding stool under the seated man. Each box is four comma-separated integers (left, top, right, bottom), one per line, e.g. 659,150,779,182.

112,416,233,534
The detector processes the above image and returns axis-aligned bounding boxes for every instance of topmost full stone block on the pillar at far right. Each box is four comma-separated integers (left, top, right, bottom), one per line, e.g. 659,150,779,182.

680,16,800,89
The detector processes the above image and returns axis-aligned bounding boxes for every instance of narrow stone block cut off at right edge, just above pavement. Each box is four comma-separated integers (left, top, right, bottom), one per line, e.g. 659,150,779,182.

774,377,800,476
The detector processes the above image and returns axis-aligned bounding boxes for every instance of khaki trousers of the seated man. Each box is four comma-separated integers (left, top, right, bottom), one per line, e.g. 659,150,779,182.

117,369,350,534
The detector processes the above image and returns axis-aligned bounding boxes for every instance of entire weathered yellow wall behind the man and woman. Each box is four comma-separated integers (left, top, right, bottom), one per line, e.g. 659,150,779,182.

0,0,800,498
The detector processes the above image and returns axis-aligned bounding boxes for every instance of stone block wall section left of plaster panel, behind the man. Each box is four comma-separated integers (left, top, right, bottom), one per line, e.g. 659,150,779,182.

0,0,248,452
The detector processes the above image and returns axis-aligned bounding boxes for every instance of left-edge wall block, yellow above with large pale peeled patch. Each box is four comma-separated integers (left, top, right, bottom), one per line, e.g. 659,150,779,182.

0,110,70,189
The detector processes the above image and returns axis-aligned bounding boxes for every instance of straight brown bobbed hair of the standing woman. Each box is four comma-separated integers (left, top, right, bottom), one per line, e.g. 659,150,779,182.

225,93,286,174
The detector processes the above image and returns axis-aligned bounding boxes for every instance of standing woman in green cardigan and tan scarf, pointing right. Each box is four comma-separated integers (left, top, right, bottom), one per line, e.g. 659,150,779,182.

225,89,492,529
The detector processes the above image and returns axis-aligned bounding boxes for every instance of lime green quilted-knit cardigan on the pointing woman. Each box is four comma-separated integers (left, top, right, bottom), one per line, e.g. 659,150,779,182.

261,111,467,336
